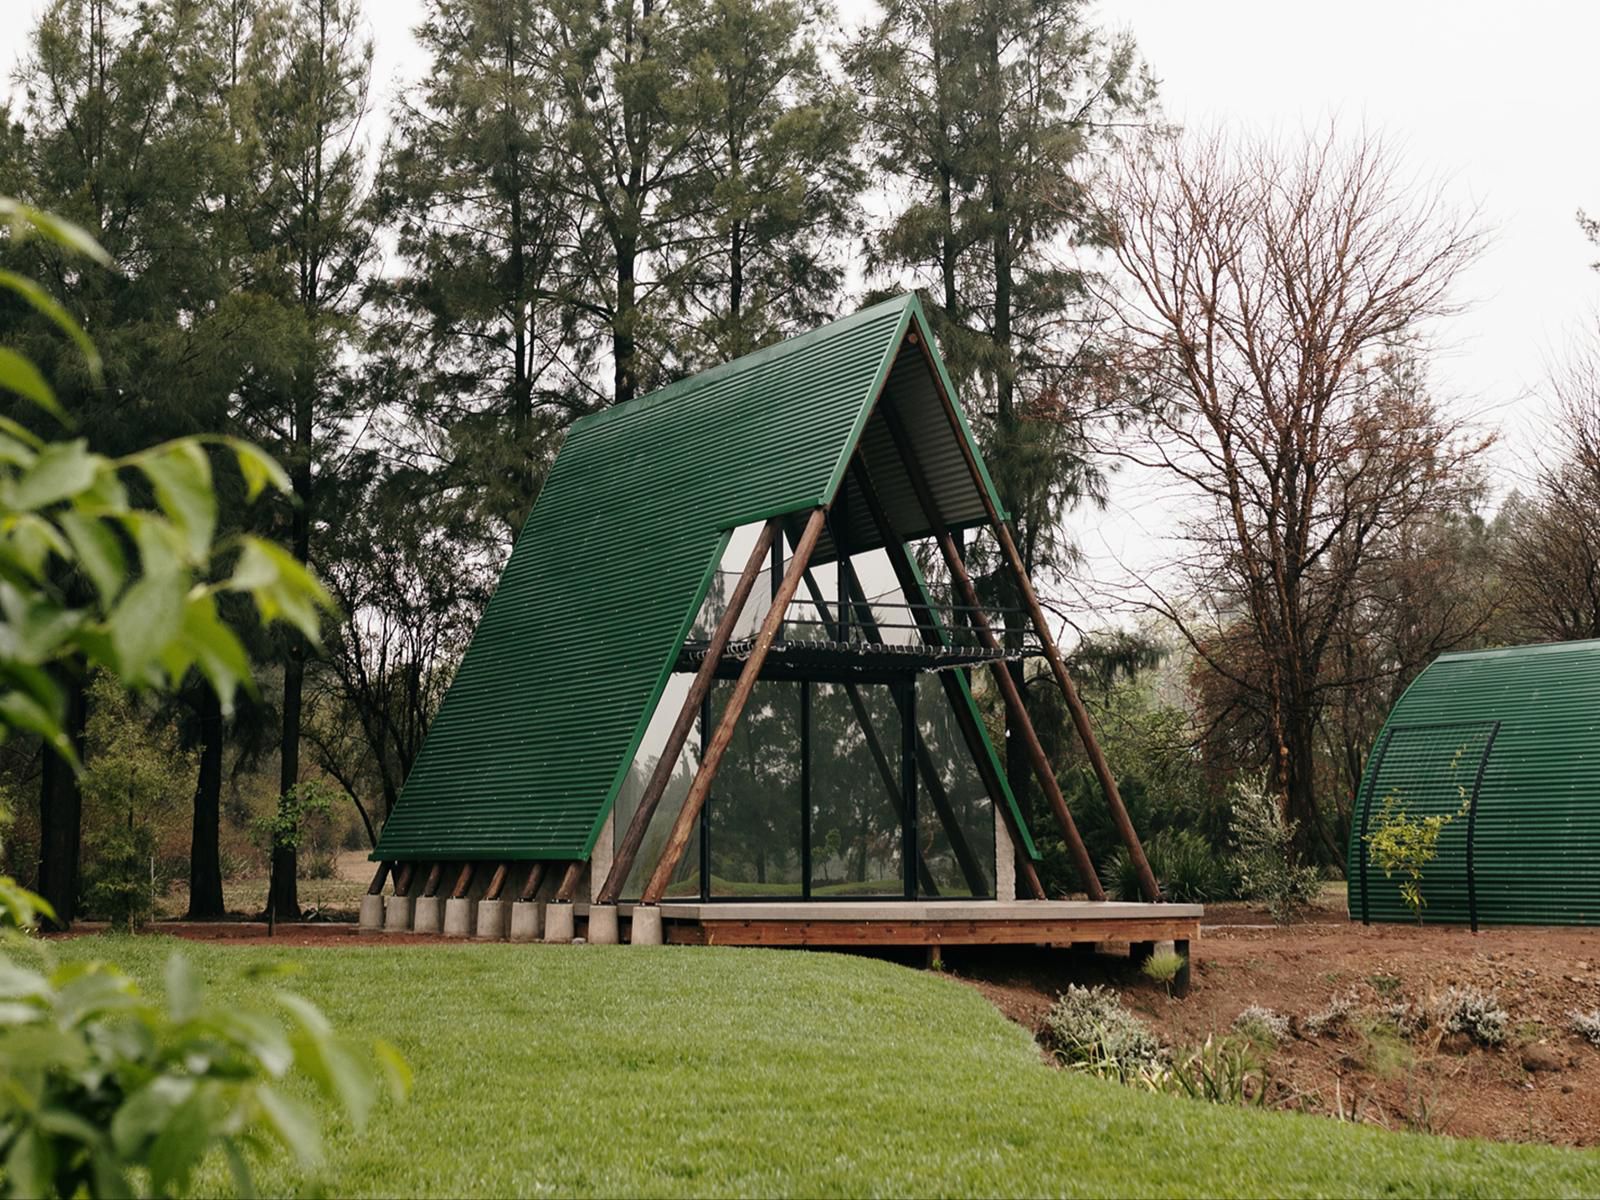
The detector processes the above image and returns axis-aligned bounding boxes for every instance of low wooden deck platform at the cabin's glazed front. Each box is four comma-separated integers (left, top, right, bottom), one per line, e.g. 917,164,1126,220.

621,901,1203,947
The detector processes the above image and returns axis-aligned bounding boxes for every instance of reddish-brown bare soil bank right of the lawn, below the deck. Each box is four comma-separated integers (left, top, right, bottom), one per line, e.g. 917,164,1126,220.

949,906,1600,1146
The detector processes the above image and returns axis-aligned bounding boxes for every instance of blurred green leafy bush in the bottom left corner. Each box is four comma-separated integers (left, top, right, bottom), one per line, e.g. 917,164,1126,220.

0,878,411,1197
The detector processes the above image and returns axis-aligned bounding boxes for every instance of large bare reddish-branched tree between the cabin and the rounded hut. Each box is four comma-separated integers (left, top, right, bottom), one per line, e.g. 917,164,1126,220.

1109,126,1486,858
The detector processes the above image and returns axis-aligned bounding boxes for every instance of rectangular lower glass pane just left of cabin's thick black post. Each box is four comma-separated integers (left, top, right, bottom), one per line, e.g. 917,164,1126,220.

811,683,906,898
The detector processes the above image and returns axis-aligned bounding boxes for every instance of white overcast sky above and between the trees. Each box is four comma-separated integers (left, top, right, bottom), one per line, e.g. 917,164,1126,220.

0,0,1600,579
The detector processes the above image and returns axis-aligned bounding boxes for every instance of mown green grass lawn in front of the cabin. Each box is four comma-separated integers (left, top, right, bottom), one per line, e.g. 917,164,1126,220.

50,938,1600,1197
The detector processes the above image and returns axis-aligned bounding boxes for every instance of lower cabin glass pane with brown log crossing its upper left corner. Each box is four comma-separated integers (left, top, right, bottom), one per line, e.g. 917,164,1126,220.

707,680,803,898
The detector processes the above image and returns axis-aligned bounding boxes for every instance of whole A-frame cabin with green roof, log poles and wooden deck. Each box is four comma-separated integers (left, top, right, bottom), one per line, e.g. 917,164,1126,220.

363,296,1200,979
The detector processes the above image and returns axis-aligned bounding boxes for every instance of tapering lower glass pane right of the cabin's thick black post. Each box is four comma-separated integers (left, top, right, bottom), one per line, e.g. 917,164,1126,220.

917,675,995,898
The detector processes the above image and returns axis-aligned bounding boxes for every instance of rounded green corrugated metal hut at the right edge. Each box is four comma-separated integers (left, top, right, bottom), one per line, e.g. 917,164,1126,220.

1349,642,1600,925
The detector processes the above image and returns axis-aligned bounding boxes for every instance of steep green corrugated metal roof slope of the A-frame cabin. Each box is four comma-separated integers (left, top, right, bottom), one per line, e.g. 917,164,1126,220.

374,296,1024,859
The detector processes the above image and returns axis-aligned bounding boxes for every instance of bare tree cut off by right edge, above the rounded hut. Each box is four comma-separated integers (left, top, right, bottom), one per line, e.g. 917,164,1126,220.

1506,330,1600,642
